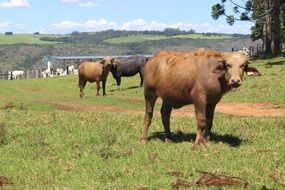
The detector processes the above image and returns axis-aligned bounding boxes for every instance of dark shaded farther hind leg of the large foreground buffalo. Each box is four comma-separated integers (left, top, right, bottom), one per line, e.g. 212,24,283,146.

160,101,172,141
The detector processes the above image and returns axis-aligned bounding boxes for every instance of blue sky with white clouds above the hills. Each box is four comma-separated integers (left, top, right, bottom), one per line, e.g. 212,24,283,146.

0,0,252,34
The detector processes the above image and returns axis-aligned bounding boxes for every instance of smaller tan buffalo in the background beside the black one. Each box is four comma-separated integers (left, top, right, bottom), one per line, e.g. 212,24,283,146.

78,57,114,98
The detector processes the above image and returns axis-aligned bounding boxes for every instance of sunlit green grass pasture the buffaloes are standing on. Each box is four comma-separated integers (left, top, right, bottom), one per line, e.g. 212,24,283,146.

0,58,285,189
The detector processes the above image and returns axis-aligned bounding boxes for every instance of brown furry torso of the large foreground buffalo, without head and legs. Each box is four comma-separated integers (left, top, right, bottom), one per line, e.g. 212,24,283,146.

144,51,224,106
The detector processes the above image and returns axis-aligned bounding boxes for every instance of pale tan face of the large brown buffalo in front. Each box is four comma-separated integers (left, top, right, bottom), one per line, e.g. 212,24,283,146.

223,52,249,88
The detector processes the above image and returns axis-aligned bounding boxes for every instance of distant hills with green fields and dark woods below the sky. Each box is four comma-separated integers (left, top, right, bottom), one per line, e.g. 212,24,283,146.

0,30,254,72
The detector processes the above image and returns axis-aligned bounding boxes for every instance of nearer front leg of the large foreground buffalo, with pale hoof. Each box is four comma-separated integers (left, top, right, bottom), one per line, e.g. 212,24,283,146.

194,100,207,145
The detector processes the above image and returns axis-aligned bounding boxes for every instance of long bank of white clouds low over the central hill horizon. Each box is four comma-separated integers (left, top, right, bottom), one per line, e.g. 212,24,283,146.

44,18,252,34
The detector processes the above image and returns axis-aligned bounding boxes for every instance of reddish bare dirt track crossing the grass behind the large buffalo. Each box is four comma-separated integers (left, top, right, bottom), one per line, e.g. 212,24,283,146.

47,101,285,117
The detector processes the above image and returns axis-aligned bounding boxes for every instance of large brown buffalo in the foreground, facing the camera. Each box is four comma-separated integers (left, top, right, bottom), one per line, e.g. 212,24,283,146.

141,49,260,145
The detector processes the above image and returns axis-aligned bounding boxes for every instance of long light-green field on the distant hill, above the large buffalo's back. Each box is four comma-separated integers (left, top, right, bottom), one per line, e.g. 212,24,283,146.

104,34,231,44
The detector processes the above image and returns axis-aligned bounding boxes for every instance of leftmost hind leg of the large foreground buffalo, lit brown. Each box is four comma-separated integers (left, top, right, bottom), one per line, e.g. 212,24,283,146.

140,93,157,144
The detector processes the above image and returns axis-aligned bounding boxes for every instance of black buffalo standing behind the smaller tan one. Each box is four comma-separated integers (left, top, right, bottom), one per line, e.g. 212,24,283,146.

111,55,148,86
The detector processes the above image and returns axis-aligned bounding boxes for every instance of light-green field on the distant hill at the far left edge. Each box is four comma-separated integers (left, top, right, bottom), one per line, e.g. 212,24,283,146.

0,34,59,45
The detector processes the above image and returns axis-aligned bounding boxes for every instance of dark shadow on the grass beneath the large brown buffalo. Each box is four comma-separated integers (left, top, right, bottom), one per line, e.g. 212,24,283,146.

148,132,243,147
